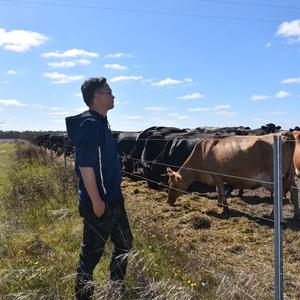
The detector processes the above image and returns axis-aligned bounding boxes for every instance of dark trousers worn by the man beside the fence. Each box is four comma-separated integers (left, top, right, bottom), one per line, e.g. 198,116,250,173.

75,200,132,300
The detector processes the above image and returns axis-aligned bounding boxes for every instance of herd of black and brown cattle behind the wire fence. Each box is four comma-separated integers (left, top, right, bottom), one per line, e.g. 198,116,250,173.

35,123,300,217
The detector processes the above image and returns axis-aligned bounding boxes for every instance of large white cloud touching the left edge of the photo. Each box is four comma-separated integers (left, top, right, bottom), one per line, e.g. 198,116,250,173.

0,28,48,53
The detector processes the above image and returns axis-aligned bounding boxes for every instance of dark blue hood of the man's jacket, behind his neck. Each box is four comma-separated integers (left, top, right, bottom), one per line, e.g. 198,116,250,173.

66,110,107,145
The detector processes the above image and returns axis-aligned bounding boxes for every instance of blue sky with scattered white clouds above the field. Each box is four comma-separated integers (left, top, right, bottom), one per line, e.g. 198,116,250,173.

0,0,300,130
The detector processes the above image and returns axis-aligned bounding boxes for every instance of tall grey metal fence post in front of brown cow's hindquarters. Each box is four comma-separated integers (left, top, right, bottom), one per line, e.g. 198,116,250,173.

273,135,283,300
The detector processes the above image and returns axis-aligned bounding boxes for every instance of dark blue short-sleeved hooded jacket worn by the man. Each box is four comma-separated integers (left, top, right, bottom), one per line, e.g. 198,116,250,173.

66,110,122,207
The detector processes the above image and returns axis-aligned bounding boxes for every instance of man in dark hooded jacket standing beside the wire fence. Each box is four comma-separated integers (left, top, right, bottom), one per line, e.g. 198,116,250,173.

66,77,132,300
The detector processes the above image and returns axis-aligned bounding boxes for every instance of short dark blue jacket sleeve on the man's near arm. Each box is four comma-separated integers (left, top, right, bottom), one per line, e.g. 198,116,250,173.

76,119,100,167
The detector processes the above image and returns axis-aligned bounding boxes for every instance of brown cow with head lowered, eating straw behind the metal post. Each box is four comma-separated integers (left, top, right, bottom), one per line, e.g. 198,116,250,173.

167,132,299,217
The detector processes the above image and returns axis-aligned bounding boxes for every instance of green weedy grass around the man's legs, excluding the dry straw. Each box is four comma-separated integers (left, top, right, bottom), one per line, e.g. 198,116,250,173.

0,144,202,299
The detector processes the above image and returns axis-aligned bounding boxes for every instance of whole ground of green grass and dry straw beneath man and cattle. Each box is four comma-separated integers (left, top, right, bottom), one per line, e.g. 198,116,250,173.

0,143,300,300
